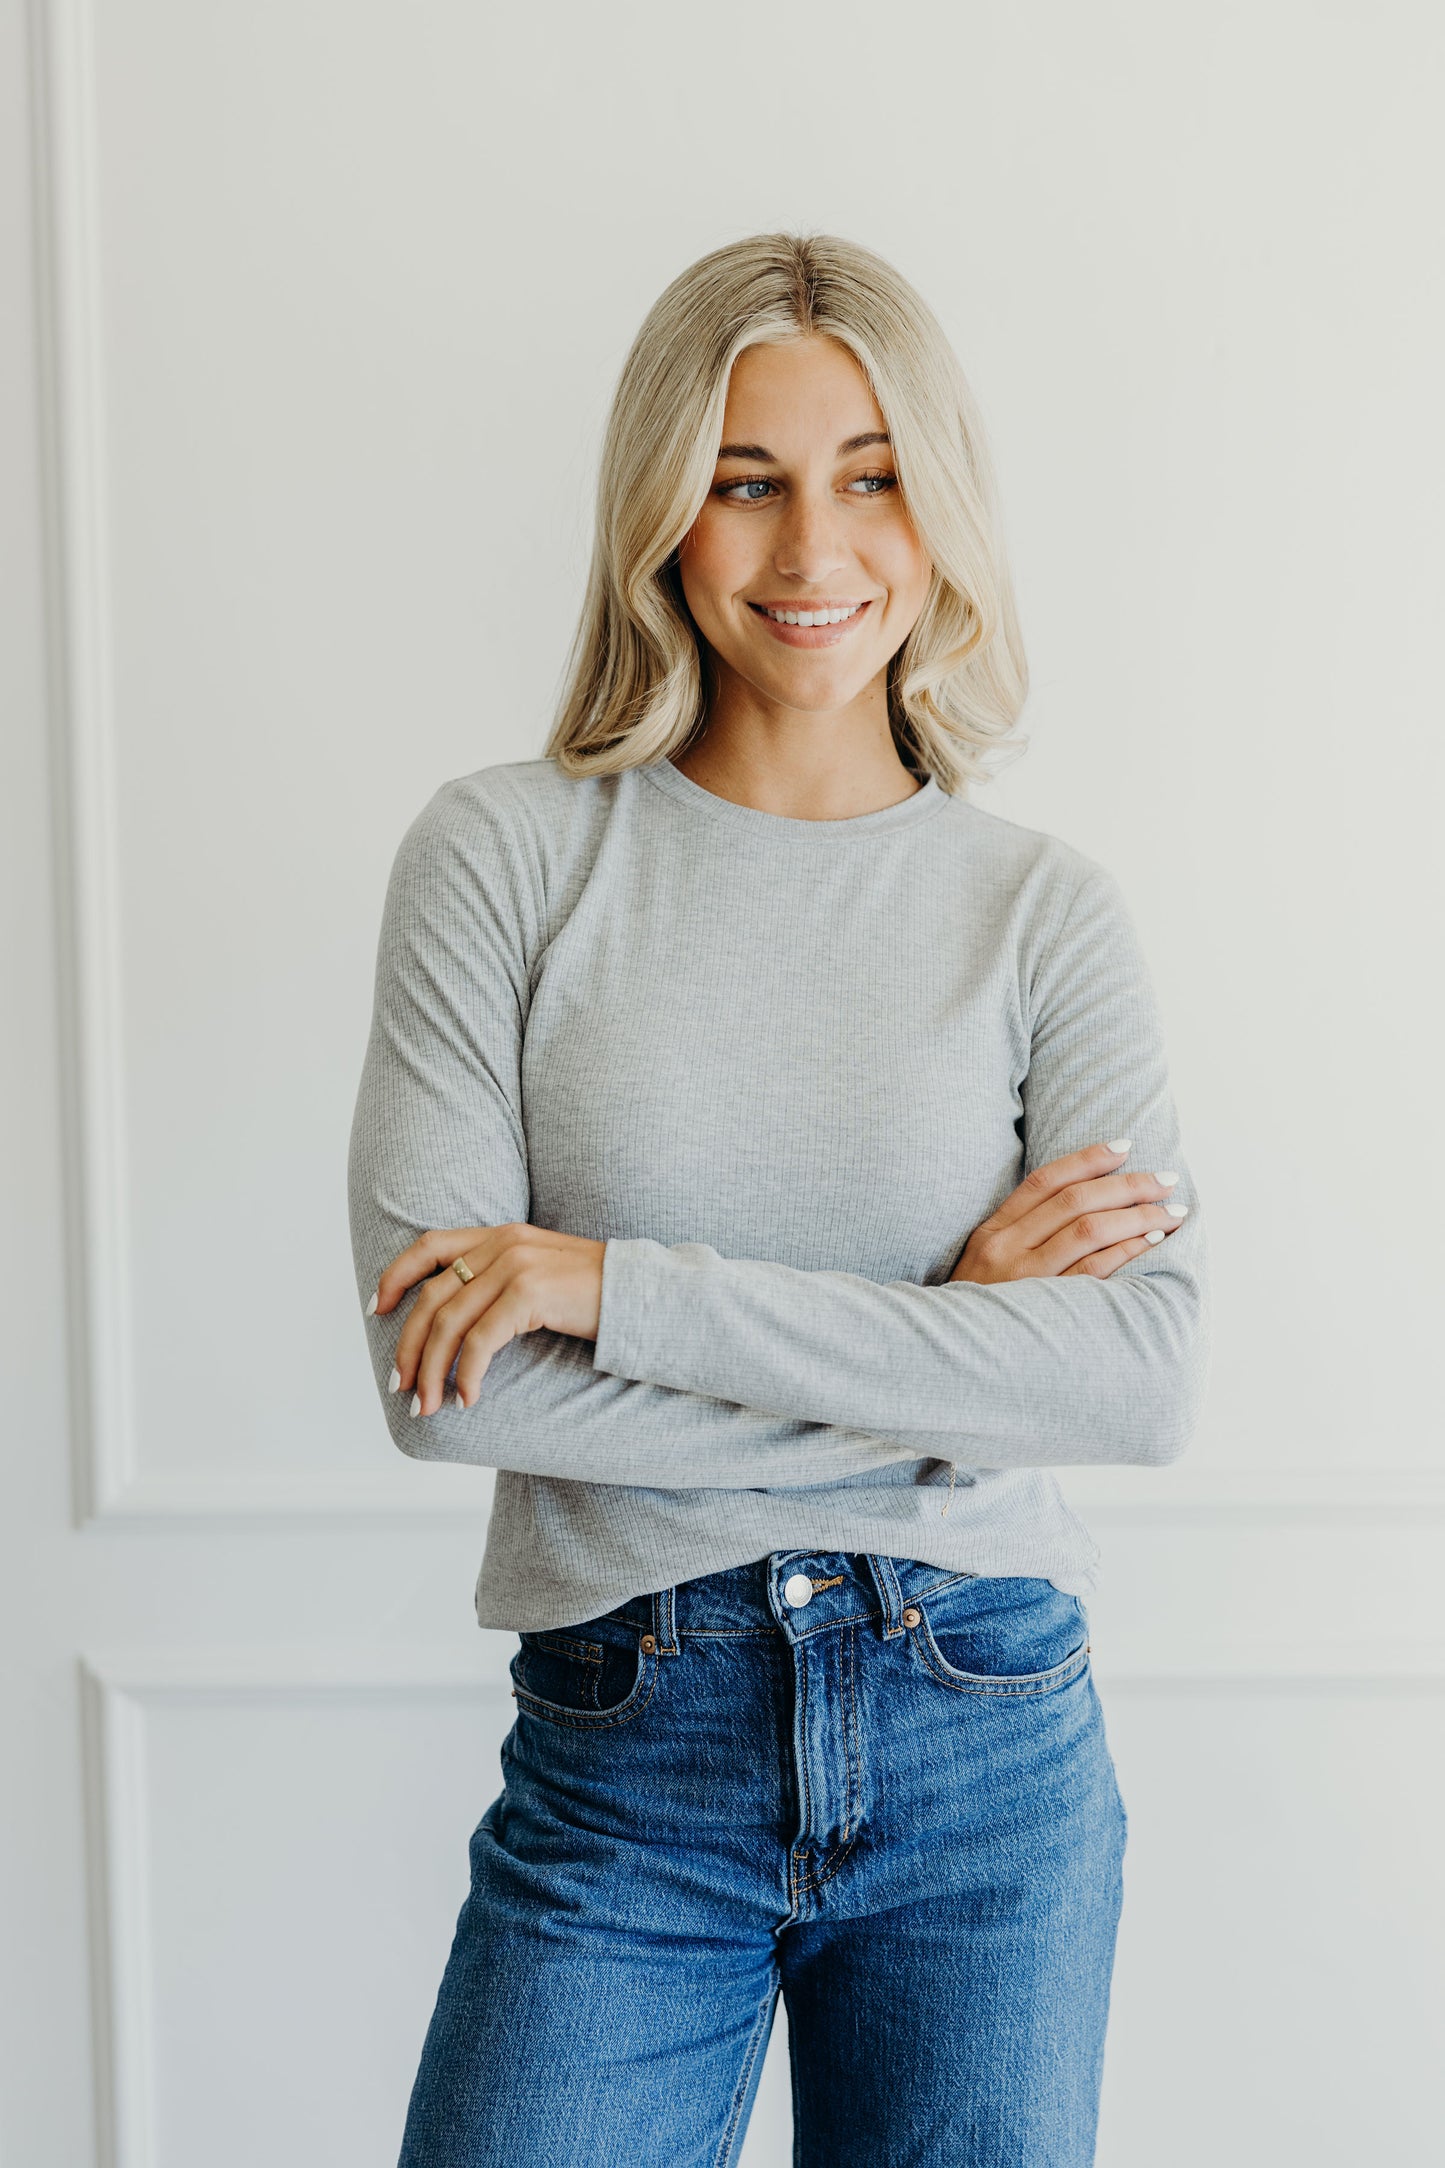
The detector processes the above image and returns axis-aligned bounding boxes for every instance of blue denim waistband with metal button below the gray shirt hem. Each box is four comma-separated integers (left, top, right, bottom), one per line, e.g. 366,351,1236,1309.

613,1550,979,1656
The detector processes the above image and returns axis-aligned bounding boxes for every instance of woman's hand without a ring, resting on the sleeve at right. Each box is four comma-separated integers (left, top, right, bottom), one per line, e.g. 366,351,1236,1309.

949,1138,1189,1286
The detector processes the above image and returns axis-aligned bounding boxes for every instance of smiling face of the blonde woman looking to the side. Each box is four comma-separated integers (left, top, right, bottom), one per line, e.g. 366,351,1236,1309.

678,338,932,715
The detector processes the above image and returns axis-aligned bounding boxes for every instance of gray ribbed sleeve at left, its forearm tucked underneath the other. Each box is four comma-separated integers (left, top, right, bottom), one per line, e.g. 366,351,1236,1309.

347,778,931,1489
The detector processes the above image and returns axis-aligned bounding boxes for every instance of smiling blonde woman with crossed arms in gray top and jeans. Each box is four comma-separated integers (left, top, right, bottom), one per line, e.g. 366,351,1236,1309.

351,234,1205,2168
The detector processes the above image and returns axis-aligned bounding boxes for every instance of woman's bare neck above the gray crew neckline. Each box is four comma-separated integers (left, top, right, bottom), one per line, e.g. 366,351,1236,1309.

672,683,921,820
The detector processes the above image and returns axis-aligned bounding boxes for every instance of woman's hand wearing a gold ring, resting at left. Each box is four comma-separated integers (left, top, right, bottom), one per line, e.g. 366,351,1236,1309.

375,1225,607,1416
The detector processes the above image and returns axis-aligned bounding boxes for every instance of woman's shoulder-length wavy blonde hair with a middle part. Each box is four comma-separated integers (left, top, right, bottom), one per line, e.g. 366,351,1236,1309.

546,234,1029,791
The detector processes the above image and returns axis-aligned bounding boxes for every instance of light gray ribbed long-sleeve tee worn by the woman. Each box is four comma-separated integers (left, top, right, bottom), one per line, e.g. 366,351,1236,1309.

349,759,1207,1628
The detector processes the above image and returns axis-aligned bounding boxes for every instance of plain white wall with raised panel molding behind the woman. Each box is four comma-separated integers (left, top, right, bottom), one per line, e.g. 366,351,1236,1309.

0,0,1445,2168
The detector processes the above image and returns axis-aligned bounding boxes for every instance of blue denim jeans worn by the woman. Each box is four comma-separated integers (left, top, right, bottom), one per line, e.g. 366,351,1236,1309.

399,1552,1127,2168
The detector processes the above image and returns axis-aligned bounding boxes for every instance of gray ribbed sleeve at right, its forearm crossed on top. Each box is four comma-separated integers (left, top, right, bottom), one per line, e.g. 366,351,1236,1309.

594,865,1207,1468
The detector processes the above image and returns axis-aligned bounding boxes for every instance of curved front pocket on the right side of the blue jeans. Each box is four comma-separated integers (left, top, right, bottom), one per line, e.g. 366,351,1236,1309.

912,1576,1090,1698
